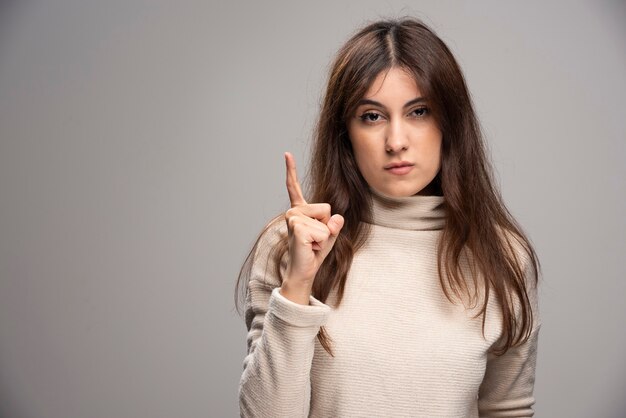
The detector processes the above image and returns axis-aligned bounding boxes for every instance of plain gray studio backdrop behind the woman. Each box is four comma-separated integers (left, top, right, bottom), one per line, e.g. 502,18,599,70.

0,0,626,418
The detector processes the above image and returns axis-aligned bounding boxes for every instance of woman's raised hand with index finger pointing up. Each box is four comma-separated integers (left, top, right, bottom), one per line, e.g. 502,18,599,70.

281,152,344,305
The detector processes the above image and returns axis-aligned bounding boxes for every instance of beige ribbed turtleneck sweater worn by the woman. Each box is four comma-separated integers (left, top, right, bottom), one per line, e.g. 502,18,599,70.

239,189,540,418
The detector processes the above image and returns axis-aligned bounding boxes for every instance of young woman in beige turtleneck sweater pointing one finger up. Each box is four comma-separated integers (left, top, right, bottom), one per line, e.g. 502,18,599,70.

235,18,540,418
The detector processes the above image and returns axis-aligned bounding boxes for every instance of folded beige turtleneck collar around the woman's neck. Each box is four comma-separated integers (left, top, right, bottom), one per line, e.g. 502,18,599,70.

369,186,446,231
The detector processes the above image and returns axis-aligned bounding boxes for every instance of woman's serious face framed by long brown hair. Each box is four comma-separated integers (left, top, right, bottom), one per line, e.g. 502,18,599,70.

348,67,442,196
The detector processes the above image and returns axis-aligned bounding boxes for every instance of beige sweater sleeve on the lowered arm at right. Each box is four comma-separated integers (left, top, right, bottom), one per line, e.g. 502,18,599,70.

478,256,541,417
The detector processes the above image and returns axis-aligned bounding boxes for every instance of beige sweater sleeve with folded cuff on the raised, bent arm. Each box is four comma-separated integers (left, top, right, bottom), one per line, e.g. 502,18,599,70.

239,222,330,418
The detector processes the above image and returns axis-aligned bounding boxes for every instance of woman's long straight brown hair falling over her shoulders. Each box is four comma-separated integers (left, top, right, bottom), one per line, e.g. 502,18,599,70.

235,17,540,355
